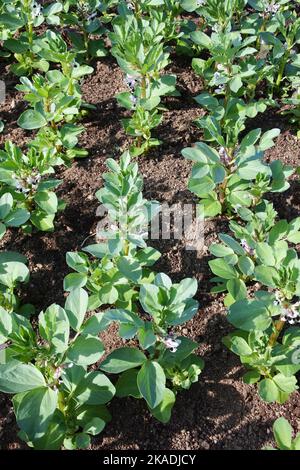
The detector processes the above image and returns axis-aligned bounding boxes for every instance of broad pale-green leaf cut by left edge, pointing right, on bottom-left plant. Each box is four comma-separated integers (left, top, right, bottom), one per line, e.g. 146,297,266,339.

0,360,46,393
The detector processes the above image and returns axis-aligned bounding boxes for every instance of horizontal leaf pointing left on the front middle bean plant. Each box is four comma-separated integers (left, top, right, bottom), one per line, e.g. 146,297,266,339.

100,347,146,374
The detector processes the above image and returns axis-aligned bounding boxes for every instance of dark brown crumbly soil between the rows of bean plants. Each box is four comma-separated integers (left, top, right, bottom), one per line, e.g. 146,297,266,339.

0,49,300,450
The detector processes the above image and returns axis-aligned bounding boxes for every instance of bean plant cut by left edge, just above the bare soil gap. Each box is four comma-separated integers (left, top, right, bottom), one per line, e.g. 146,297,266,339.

0,141,65,232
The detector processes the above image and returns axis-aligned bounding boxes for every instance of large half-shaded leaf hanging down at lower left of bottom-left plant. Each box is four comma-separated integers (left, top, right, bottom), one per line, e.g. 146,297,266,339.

13,387,58,440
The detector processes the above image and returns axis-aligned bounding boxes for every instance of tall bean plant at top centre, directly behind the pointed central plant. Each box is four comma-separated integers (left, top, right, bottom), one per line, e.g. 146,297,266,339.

109,10,176,155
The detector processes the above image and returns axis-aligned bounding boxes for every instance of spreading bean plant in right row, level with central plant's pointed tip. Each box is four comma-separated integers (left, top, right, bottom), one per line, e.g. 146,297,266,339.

182,127,294,217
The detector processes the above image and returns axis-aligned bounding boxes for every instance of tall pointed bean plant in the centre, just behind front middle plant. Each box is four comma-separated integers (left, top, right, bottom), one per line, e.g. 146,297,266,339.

64,152,160,309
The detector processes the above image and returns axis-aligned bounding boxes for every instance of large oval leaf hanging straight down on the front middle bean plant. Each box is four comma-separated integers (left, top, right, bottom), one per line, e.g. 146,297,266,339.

137,360,166,409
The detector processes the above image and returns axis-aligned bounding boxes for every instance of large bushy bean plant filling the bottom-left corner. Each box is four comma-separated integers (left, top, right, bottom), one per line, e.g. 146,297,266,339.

0,289,115,450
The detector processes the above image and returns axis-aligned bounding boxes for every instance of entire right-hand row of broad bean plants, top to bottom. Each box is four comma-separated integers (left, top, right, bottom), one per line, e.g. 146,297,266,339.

182,1,300,450
